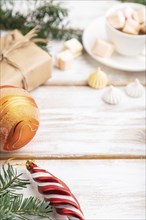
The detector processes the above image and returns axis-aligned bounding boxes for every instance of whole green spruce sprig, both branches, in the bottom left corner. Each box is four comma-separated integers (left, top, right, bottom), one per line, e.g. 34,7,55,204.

0,164,52,220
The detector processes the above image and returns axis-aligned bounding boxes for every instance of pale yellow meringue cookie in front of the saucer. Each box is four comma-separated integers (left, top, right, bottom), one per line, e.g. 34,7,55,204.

88,68,108,89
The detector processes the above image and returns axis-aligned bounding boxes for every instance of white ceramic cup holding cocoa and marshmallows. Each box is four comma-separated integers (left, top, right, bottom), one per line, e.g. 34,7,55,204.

106,3,146,56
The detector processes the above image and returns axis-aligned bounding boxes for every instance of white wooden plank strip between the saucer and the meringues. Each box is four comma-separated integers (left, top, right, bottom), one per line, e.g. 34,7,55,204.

45,49,146,86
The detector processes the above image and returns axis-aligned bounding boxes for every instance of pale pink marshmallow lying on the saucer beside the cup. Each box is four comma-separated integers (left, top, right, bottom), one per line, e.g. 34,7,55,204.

92,39,114,57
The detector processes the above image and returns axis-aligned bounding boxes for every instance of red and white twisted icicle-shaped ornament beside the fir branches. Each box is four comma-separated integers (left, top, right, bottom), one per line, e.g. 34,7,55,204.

26,160,85,220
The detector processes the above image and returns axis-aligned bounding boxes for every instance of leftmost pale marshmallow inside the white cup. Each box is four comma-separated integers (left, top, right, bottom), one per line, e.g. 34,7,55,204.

107,11,125,29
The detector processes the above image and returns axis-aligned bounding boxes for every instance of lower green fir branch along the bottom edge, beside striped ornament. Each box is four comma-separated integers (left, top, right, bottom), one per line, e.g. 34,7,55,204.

0,193,52,220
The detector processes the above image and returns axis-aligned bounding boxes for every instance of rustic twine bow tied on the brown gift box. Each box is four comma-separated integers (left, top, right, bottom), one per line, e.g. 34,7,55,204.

0,27,48,90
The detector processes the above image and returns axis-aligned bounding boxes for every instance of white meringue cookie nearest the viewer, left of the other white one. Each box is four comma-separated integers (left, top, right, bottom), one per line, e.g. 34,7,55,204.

103,86,122,105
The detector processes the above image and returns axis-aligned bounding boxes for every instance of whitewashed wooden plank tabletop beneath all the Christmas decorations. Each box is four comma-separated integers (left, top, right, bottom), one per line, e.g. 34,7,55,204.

1,1,146,220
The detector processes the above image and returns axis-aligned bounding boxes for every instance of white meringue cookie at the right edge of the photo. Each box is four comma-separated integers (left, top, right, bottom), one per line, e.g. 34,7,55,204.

126,79,144,98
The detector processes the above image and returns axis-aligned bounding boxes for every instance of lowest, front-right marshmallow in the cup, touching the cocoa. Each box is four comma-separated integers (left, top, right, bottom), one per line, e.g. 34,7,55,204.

122,19,140,34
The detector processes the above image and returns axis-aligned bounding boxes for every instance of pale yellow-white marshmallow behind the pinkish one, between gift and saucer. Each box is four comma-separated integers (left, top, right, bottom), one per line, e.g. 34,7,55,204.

63,38,83,57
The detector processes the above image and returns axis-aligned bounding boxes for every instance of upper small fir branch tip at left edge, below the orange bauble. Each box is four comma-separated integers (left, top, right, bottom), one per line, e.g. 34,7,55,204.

0,164,29,195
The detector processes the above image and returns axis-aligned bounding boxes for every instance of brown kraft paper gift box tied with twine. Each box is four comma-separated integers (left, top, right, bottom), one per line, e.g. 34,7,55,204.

0,30,51,91
